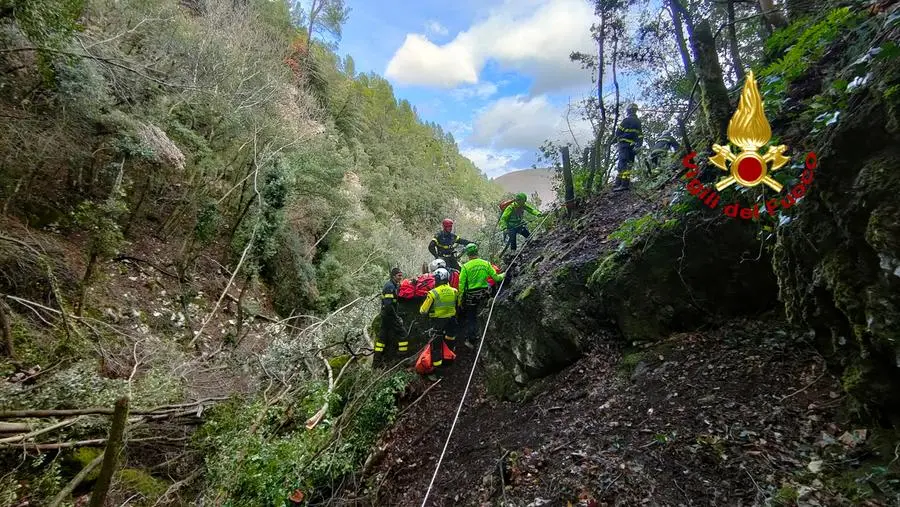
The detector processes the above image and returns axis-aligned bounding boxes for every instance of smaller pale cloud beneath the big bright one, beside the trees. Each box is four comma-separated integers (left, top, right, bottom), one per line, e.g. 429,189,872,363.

467,95,592,150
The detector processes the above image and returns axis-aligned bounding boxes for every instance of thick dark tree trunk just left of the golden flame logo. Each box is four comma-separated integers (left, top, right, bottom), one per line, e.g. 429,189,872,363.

691,20,731,144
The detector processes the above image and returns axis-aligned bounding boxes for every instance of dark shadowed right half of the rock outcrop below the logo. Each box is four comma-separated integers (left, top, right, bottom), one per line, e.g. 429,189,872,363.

591,218,776,341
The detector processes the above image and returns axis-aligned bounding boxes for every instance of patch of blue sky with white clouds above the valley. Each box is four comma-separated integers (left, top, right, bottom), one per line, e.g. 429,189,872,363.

339,0,624,177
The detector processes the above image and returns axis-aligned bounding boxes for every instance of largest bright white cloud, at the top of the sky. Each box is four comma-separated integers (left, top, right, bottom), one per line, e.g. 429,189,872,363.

385,0,594,93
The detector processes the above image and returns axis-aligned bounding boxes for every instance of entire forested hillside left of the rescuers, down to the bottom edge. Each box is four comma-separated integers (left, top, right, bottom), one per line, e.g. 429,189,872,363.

0,0,501,505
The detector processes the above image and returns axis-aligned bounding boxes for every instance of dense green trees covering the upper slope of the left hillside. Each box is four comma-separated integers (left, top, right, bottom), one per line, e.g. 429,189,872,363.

0,0,499,314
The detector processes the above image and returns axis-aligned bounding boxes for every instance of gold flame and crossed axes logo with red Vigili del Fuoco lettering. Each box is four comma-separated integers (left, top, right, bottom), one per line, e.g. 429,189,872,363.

681,71,818,220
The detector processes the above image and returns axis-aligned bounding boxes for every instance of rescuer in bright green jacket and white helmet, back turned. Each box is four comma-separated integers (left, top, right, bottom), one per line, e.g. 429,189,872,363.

458,245,509,348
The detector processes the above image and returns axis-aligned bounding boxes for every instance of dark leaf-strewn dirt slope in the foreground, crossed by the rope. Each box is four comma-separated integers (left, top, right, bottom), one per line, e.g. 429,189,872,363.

344,321,887,506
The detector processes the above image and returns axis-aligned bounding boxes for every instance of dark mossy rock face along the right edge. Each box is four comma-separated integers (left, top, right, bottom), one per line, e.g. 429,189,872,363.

773,17,900,418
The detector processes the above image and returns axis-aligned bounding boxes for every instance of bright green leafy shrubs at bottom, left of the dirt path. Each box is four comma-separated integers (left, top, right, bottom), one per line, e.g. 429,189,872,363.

196,372,410,505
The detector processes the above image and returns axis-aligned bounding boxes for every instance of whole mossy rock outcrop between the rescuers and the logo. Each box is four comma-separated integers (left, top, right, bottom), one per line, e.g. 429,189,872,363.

486,192,777,384
